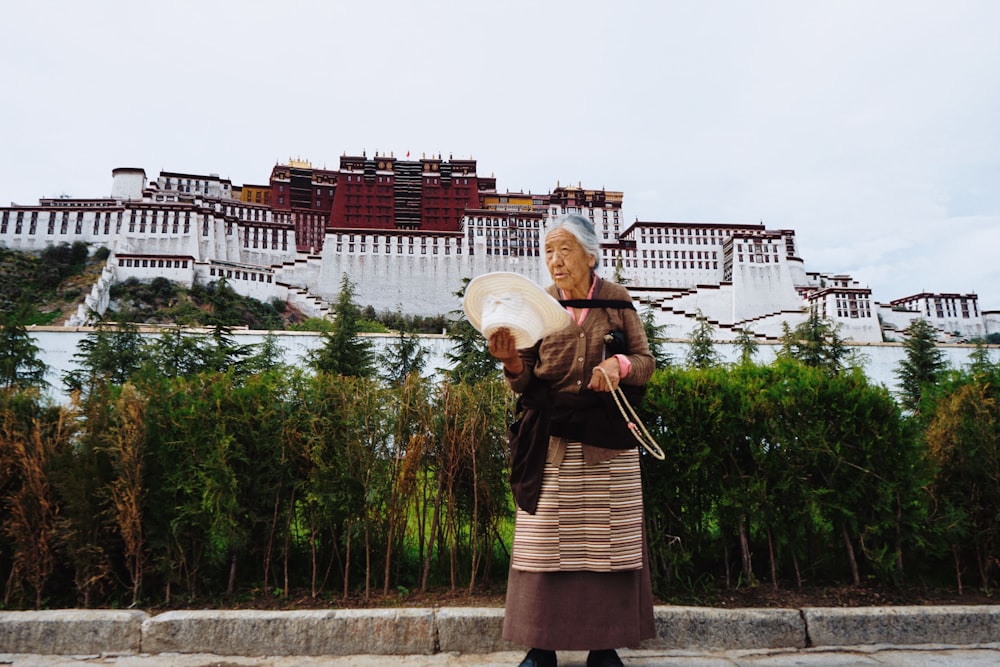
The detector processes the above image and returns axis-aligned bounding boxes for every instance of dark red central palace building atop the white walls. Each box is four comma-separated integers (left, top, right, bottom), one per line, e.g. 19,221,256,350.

270,154,496,254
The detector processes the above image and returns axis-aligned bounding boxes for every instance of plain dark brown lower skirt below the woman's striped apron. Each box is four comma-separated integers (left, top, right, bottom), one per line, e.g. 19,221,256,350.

503,443,656,650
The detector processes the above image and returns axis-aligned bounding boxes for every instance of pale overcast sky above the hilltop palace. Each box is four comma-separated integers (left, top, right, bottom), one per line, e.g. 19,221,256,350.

0,0,1000,310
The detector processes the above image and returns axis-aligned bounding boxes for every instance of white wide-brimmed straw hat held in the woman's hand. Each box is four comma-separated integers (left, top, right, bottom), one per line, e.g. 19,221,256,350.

462,271,572,349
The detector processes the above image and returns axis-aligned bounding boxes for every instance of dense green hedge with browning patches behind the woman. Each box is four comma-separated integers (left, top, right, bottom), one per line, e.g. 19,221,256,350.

0,361,1000,608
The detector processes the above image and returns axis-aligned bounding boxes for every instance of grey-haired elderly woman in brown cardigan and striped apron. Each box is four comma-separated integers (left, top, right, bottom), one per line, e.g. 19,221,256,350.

489,215,655,667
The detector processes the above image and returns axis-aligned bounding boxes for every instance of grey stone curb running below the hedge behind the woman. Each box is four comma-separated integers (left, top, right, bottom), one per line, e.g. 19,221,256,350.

0,605,1000,657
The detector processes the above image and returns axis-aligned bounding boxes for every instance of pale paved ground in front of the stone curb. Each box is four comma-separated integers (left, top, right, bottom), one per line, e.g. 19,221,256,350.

0,644,1000,667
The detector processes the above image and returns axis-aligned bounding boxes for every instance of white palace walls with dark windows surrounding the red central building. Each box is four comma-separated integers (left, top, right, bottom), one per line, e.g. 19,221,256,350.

0,169,1000,342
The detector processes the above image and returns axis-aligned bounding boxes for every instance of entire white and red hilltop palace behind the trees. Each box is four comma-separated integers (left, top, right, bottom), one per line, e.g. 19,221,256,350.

0,154,1000,343
